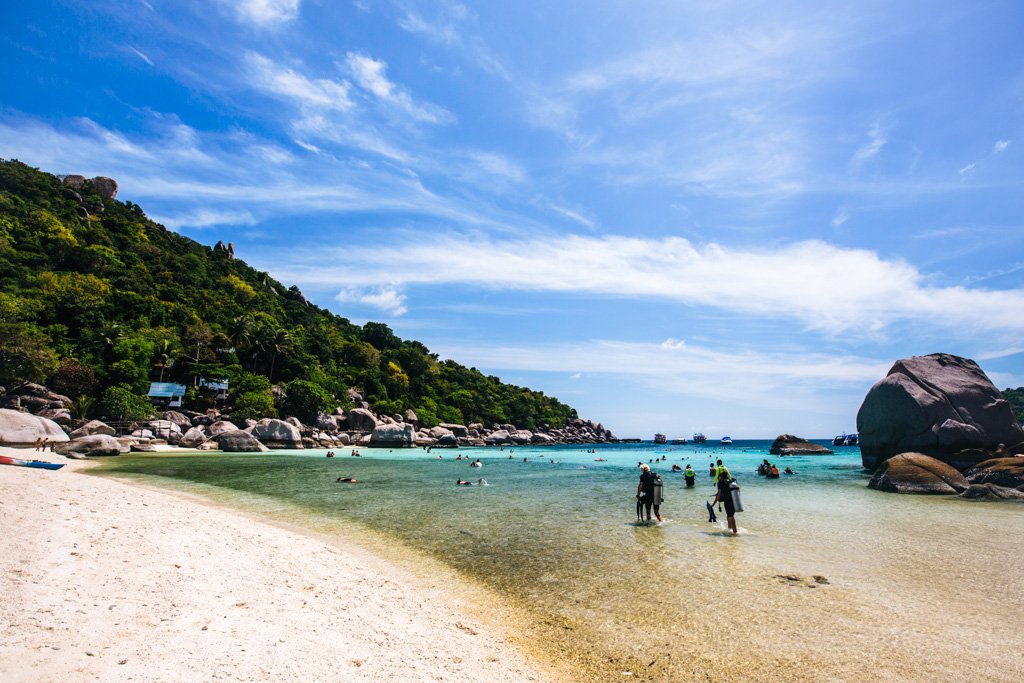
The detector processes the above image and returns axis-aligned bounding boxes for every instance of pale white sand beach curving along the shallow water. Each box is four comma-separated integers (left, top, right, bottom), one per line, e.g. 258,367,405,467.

0,447,555,683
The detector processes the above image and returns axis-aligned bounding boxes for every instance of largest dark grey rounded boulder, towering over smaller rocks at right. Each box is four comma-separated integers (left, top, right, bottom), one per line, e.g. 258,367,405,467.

857,353,1024,469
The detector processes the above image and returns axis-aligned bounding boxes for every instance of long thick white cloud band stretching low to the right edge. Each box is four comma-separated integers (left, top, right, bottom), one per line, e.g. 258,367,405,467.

276,234,1024,336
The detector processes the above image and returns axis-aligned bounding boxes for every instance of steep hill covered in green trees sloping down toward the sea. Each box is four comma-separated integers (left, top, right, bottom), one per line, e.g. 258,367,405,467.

0,160,577,429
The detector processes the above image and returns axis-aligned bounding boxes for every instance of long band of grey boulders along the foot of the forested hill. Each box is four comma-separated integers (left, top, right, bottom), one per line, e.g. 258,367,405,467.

0,384,618,457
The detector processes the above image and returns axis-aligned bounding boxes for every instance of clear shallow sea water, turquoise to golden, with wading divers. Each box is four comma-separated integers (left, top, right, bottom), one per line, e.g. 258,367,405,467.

96,441,1024,681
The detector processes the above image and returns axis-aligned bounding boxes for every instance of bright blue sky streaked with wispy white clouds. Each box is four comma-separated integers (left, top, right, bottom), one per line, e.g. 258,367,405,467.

0,0,1024,438
